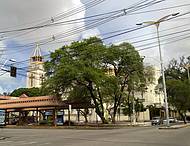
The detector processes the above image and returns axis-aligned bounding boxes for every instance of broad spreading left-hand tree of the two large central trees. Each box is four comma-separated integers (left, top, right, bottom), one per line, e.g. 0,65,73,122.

43,38,107,123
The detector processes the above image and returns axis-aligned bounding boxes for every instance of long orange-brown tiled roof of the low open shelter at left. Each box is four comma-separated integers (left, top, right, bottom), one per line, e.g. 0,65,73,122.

0,96,94,109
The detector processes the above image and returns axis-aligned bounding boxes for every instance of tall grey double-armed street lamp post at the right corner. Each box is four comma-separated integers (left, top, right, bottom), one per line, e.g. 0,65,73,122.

137,13,179,127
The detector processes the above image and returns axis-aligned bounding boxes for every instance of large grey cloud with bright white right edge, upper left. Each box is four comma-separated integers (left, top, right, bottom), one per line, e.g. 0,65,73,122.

0,0,85,50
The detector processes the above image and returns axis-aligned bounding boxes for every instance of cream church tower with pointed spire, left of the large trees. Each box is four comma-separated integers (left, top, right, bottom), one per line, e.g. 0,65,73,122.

26,44,45,88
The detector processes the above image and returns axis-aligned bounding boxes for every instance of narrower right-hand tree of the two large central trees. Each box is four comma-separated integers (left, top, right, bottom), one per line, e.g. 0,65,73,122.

103,43,145,123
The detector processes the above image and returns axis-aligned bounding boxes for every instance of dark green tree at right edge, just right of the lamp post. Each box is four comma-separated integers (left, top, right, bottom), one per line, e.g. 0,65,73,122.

165,56,190,123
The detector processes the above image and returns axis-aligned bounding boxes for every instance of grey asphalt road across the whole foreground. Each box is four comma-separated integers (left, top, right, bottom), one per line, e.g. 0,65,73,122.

0,127,190,146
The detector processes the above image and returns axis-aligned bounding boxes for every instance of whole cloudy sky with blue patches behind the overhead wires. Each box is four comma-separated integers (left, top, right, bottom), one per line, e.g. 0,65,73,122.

0,0,190,93
